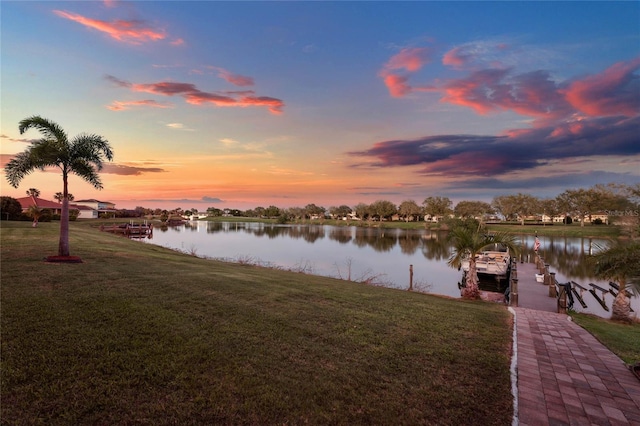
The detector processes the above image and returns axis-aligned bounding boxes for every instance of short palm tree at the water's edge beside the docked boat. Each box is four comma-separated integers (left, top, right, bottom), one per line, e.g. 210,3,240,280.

447,225,520,299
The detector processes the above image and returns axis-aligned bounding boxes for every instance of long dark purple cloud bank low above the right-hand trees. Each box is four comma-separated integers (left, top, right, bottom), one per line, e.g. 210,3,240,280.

348,116,640,176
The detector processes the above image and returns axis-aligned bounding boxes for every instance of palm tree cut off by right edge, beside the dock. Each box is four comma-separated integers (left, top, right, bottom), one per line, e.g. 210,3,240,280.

593,241,640,322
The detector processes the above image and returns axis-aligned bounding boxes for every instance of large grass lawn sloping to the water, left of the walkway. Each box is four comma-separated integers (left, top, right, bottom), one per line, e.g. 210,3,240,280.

0,222,512,425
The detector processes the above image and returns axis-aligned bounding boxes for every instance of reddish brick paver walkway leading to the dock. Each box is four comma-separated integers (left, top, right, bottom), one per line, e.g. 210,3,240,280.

514,307,640,426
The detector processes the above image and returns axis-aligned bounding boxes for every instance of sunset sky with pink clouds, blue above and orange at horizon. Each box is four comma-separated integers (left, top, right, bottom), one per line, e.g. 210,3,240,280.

0,1,640,211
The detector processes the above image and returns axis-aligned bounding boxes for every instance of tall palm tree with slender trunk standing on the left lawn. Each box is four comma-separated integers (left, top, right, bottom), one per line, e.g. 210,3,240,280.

5,115,113,256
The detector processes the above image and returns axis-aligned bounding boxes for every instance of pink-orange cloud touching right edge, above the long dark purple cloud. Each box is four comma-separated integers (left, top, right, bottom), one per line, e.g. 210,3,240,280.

564,57,640,117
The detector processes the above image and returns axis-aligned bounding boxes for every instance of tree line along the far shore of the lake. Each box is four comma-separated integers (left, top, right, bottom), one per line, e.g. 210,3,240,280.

0,183,640,230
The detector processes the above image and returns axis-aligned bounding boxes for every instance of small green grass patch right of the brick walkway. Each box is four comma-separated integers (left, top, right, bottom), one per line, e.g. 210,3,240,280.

571,313,640,365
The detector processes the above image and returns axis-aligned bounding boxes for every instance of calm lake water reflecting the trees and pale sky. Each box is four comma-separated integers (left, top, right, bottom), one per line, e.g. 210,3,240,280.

143,221,640,317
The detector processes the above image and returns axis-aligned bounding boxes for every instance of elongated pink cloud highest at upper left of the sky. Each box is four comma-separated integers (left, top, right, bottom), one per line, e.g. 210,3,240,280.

53,10,166,44
